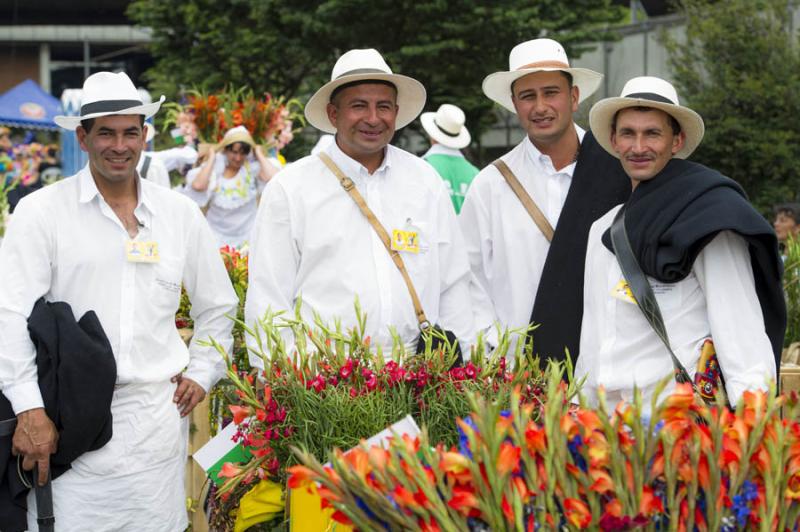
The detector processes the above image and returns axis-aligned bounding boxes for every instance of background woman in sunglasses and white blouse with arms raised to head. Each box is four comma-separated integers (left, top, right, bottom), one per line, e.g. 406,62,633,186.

184,126,279,247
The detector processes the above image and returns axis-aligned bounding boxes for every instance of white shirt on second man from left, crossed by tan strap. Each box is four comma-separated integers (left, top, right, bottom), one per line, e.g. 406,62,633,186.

245,142,474,364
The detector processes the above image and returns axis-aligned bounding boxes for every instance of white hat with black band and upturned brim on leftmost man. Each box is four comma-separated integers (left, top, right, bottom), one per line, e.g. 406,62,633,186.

53,72,164,131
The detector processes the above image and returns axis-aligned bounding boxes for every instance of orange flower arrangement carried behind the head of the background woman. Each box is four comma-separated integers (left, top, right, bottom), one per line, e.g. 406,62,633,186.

165,87,303,150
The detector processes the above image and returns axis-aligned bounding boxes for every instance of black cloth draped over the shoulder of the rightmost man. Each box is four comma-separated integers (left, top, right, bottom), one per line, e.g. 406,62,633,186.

603,159,786,370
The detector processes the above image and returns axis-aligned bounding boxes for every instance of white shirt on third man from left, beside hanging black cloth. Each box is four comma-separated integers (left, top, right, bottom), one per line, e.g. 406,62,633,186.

459,126,585,338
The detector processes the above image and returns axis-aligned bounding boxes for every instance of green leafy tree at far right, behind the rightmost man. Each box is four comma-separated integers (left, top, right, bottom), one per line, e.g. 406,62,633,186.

665,0,800,212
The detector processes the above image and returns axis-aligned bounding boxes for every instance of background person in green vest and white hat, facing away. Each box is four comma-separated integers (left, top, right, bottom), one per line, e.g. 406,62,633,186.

419,103,478,214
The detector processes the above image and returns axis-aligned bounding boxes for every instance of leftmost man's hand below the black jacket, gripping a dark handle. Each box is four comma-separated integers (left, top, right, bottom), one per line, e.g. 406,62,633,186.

11,408,58,486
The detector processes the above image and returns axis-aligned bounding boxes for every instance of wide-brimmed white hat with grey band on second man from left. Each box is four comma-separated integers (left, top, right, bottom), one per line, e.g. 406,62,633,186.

305,48,426,133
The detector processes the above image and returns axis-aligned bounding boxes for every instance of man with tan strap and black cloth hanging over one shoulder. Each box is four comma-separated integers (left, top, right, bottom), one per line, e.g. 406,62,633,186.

460,39,630,360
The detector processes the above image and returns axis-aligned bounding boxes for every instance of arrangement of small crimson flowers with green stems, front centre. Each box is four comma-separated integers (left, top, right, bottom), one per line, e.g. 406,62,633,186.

203,310,543,529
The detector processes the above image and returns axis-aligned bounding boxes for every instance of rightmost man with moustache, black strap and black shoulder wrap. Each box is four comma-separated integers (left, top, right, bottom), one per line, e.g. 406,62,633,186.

575,77,786,404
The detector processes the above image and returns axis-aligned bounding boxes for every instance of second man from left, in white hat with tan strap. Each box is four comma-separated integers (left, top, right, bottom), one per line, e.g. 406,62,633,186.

245,49,473,365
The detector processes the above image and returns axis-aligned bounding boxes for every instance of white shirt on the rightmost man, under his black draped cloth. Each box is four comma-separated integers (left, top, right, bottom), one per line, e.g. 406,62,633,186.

575,207,775,406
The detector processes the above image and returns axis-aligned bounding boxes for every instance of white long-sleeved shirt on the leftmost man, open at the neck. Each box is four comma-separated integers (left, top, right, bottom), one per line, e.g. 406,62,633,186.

0,165,237,412
